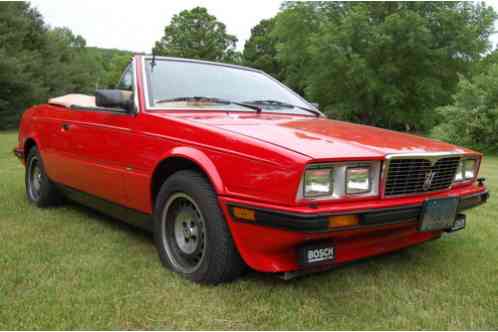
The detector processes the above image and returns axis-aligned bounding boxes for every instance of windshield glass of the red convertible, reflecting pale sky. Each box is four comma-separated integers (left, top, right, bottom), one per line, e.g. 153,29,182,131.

145,59,313,114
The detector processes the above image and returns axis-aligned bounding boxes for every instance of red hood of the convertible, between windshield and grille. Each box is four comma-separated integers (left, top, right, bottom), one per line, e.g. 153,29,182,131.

169,113,472,159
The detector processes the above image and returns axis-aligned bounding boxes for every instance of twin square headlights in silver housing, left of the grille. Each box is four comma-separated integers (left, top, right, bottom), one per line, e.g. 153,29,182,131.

297,161,381,200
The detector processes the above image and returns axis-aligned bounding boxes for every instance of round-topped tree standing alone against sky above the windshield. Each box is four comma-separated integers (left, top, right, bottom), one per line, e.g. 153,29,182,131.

154,7,238,62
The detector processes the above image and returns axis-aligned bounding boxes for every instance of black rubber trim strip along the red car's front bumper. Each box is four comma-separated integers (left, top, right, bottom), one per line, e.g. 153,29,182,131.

227,191,489,232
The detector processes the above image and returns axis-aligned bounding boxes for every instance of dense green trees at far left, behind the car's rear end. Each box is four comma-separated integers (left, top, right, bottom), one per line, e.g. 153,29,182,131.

0,2,131,129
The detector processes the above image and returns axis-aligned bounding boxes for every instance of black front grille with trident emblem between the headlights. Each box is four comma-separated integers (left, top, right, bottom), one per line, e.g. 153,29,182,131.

384,156,460,196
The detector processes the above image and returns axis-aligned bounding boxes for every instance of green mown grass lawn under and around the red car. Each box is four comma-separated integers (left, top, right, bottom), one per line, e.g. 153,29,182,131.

0,132,498,330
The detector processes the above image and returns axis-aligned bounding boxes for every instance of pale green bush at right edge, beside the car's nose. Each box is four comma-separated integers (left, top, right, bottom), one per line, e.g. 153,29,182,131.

432,64,498,152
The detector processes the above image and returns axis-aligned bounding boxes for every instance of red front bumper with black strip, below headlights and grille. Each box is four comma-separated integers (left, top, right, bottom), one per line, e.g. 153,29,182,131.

220,187,489,272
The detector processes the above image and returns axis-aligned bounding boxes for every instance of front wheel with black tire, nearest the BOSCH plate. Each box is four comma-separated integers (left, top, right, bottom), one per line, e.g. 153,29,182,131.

154,170,245,285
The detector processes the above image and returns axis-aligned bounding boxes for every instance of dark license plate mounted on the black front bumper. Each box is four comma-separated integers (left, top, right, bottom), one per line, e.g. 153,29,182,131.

419,197,458,232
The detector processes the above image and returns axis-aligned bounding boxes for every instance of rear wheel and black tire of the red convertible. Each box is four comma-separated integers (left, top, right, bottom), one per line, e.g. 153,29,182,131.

24,147,61,208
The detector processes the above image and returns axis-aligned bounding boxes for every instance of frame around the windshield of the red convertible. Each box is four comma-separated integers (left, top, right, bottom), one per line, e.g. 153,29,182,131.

141,55,324,117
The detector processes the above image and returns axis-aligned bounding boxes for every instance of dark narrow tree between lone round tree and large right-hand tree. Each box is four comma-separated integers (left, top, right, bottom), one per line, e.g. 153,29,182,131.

242,18,282,79
